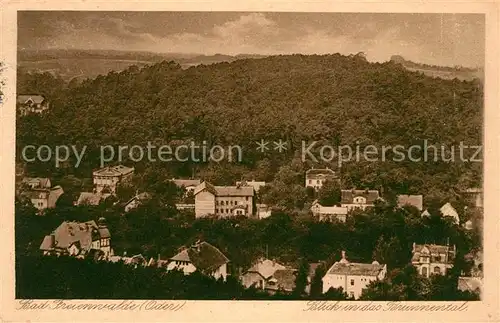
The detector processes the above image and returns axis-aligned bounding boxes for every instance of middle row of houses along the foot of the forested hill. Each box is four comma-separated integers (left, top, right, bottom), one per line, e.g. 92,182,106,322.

17,165,482,229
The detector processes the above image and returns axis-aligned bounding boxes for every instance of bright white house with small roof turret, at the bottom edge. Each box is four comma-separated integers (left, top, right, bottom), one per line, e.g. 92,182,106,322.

322,251,387,299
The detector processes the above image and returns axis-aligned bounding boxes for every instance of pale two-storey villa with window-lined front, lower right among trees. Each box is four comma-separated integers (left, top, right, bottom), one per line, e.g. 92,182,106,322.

411,243,456,277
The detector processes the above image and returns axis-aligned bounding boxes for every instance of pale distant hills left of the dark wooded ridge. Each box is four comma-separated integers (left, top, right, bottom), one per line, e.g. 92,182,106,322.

18,49,265,81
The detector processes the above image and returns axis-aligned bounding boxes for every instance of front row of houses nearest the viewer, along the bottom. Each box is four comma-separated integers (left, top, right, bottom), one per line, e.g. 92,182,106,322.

36,214,481,299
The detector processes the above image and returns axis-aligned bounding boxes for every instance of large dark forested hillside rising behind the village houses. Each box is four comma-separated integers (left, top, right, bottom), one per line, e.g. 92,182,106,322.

17,54,483,200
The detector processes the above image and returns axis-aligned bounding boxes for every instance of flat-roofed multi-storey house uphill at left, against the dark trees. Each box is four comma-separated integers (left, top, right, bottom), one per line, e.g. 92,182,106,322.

92,165,134,194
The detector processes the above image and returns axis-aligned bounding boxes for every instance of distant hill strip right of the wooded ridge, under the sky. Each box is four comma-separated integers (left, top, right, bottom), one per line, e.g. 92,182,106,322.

391,55,484,81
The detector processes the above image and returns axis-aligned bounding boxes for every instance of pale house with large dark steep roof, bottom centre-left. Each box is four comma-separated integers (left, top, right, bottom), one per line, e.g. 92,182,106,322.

166,241,229,280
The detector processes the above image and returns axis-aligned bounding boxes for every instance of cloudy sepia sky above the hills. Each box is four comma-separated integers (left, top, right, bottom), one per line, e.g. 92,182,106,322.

18,11,485,67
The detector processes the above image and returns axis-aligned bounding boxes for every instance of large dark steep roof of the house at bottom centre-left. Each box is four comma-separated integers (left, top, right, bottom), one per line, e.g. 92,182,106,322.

170,242,229,273
